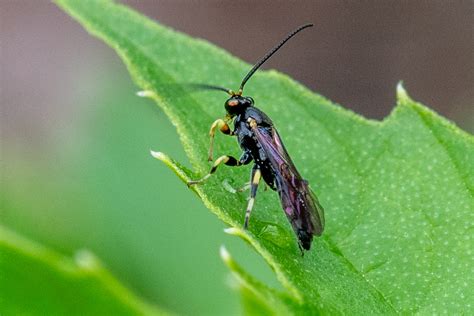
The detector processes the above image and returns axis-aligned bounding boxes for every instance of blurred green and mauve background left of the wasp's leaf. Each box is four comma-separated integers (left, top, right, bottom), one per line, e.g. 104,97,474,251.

0,3,278,315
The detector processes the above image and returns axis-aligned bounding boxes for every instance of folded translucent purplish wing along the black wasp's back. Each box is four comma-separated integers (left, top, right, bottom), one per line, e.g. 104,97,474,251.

253,126,324,241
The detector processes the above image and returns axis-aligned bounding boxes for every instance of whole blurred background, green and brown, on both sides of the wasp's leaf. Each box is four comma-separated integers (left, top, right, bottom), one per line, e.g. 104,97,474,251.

0,1,474,314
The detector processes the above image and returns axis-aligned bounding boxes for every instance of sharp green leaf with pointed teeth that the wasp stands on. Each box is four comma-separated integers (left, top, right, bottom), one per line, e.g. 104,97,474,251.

53,0,474,315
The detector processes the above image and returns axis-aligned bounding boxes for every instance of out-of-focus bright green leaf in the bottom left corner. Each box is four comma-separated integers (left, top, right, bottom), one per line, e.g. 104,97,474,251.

0,226,167,315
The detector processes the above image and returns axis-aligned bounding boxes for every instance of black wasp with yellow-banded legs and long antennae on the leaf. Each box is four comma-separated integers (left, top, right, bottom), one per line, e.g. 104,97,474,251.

188,24,324,250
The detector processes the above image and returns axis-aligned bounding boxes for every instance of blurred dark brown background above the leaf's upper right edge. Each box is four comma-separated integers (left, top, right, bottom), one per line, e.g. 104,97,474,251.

128,0,474,131
